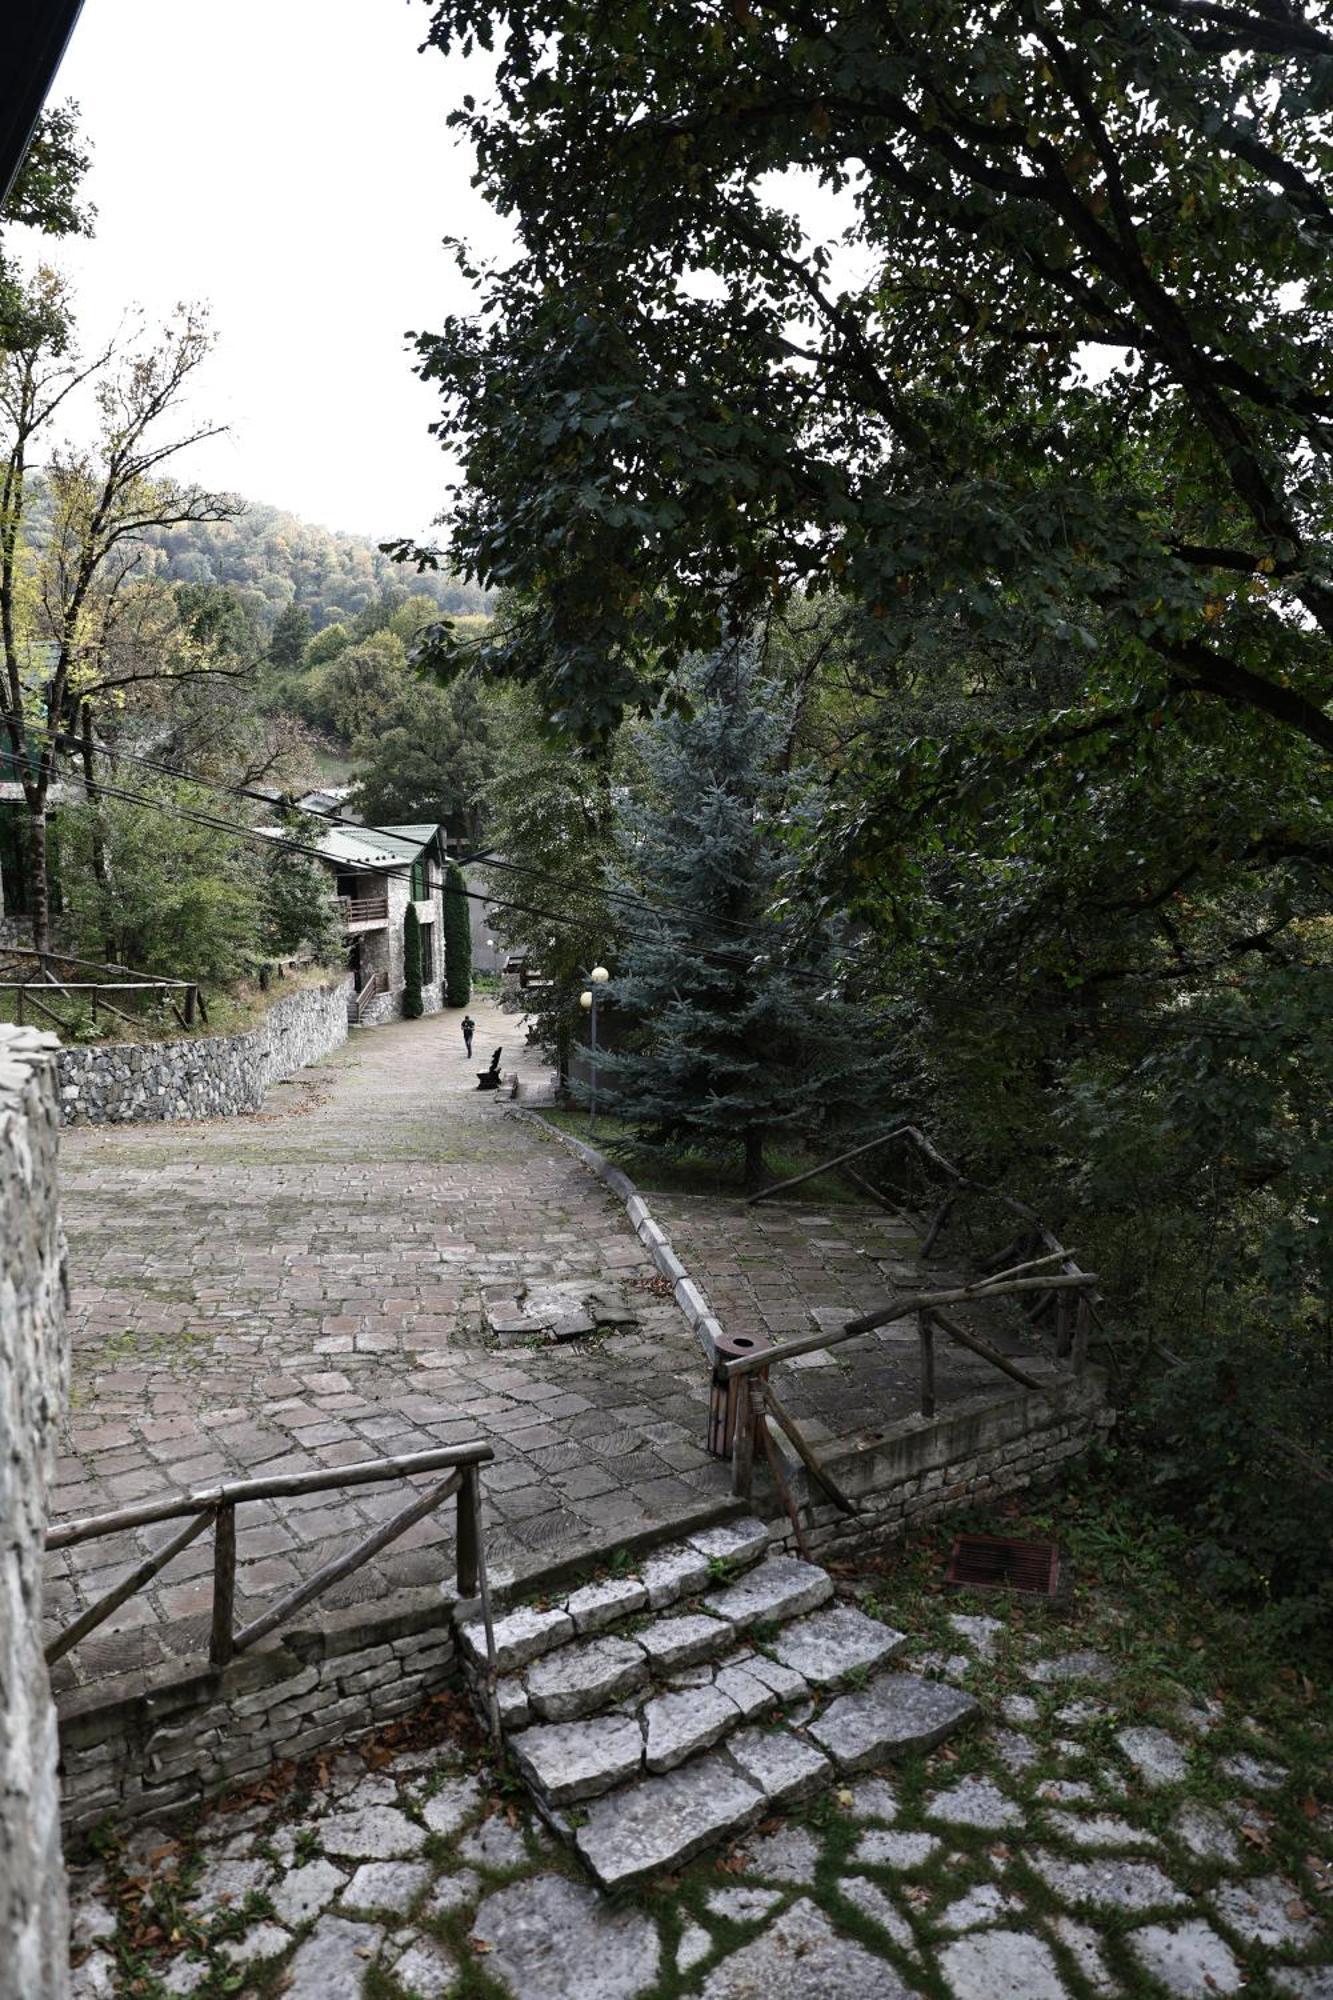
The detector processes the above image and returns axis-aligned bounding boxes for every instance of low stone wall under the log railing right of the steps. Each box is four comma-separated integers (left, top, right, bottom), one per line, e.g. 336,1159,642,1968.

769,1368,1115,1562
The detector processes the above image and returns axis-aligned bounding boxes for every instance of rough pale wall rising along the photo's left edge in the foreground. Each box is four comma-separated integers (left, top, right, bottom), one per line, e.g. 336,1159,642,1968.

0,1026,70,2000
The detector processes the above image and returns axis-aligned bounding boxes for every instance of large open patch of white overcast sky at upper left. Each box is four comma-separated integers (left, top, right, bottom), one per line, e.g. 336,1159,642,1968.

10,0,506,538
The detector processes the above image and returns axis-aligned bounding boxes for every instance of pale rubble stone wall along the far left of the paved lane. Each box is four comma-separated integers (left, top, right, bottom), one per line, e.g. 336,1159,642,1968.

60,976,350,1124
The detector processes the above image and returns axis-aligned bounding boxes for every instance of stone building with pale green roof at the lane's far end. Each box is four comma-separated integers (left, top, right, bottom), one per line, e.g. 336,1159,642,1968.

262,824,444,1028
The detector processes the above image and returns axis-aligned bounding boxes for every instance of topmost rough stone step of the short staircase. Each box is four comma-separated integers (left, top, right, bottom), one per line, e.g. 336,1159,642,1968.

458,1516,769,1674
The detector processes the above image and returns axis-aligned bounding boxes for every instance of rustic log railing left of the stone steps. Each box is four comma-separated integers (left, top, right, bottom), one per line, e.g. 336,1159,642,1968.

46,1440,494,1736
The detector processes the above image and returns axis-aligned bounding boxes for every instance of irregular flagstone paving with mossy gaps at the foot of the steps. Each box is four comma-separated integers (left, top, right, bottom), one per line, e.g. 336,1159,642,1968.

74,1582,1333,2000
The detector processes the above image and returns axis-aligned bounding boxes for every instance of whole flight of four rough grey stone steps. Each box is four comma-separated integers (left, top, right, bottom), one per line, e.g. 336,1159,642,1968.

458,1520,977,1888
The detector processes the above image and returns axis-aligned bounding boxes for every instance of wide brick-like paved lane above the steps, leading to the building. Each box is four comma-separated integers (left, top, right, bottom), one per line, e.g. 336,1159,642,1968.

48,1004,727,1688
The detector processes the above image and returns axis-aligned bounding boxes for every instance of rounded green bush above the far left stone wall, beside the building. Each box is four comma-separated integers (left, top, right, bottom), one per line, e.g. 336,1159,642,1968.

62,778,262,982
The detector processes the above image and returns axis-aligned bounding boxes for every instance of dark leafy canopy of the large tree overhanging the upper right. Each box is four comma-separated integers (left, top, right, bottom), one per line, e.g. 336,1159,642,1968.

418,0,1333,754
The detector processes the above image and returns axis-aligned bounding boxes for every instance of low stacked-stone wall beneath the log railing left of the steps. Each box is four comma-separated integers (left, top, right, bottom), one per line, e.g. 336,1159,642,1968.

58,1590,454,1840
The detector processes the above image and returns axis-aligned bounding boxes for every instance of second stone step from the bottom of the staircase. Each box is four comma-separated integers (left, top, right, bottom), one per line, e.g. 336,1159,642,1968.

510,1606,903,1808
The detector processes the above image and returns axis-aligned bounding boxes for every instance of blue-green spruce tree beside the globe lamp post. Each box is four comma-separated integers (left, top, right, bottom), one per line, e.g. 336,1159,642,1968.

598,646,873,1192
